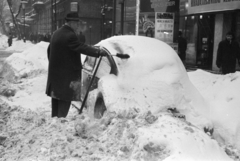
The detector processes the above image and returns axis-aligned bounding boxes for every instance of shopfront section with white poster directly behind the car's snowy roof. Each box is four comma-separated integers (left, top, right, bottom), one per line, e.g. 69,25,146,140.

116,0,179,51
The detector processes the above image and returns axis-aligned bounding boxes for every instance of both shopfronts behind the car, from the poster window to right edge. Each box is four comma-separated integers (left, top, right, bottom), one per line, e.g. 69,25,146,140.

116,0,240,71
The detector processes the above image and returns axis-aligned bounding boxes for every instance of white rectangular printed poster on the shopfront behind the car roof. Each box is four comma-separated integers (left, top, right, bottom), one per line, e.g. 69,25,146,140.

155,12,174,43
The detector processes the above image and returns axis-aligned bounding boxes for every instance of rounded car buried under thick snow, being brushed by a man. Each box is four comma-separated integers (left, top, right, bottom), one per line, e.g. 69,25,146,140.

82,35,209,126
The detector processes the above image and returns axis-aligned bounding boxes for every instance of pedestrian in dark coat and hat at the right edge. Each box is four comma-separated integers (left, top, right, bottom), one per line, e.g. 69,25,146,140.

216,32,240,74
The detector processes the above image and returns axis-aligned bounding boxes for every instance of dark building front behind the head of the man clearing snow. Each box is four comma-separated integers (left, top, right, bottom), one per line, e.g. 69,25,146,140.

27,0,113,44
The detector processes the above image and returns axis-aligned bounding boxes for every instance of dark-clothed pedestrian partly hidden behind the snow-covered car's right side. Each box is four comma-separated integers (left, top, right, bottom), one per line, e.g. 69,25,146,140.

178,31,187,65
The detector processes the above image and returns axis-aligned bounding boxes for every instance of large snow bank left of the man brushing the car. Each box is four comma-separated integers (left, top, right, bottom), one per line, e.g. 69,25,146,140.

0,42,49,81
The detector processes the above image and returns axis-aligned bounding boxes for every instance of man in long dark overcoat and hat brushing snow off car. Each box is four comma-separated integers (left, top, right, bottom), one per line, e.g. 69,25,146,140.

46,13,107,117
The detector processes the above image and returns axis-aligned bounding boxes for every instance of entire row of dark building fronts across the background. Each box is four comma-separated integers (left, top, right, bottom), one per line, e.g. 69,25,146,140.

19,0,240,70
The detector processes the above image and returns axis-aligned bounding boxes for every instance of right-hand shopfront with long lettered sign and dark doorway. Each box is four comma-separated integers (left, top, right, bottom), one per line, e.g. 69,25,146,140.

179,0,240,71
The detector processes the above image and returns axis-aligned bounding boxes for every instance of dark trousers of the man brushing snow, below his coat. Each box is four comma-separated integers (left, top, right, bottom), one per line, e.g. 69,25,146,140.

52,98,71,117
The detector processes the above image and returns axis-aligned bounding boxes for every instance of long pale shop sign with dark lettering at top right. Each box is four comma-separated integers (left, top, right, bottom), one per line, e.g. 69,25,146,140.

186,0,240,14
